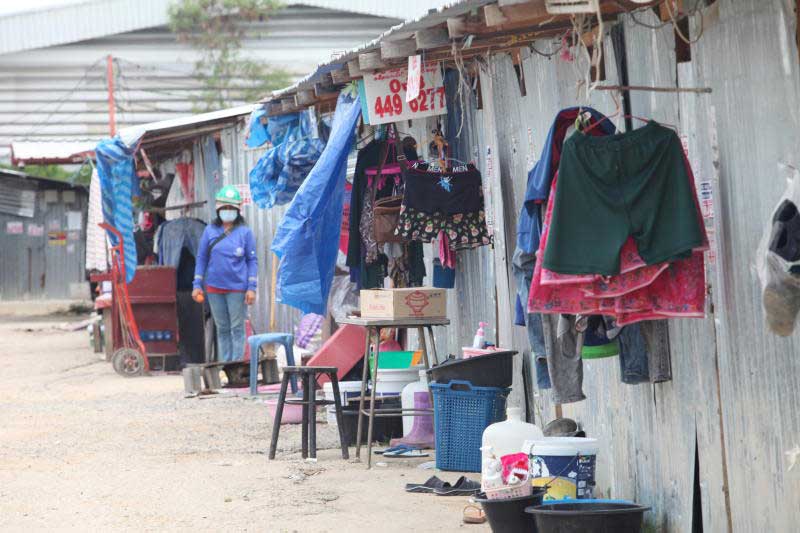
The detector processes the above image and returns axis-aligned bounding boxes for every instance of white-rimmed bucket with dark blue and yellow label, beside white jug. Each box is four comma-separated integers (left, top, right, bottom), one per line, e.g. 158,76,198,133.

523,437,600,500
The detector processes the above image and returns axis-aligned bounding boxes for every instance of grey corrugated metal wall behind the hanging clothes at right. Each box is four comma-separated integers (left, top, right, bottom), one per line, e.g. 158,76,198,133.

180,4,800,533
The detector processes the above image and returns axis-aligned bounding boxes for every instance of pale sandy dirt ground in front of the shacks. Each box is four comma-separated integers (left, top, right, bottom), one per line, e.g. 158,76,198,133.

0,305,489,533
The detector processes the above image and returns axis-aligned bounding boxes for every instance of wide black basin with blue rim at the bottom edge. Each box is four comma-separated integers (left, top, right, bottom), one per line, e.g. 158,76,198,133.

528,500,650,533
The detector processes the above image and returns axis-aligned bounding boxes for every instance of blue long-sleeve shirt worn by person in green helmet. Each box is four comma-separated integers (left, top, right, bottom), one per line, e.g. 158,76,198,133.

194,224,258,291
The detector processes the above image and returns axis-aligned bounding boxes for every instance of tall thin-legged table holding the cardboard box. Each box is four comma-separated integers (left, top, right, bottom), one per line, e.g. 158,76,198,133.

339,317,450,468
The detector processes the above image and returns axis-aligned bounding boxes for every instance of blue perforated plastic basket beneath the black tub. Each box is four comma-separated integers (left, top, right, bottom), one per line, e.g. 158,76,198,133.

431,380,511,472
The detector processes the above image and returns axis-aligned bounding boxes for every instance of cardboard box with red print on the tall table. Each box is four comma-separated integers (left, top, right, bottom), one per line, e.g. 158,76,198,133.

361,287,447,318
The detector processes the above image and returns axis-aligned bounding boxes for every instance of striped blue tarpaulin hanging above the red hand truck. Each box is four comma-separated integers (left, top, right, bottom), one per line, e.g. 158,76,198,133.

95,136,139,283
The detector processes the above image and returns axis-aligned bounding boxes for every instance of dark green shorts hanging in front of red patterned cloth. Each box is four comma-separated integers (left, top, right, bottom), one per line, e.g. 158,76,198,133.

543,122,703,276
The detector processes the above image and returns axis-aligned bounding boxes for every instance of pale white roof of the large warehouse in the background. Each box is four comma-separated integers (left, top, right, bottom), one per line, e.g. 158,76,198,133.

0,0,456,54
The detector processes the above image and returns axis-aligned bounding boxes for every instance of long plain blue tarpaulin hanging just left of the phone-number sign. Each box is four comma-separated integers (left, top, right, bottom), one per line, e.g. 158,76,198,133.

272,91,361,315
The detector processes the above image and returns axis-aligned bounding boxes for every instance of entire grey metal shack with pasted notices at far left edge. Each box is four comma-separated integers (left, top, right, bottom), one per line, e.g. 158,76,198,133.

0,169,89,300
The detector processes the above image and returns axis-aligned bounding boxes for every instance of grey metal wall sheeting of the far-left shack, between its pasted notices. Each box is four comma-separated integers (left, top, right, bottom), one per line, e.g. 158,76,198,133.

0,180,89,300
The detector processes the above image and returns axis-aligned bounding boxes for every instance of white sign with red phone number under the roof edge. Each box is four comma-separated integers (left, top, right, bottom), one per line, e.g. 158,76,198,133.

364,63,447,125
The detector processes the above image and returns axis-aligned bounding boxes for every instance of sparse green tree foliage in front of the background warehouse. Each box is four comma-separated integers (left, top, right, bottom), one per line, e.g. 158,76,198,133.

169,0,291,111
